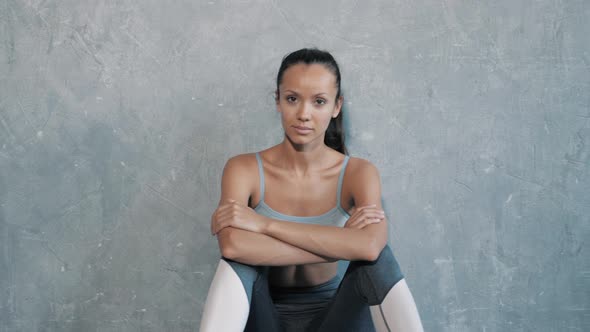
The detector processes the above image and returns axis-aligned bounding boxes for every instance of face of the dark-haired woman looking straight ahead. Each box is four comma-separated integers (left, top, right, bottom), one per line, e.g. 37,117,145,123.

277,63,342,145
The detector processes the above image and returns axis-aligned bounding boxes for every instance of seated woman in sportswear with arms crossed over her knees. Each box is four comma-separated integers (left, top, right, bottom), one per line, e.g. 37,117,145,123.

201,49,422,332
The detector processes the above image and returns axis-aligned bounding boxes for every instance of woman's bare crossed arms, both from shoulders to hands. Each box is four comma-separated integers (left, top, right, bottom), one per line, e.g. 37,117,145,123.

211,155,387,266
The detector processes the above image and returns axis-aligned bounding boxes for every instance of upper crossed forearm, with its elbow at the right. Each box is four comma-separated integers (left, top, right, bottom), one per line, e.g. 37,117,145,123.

262,218,387,261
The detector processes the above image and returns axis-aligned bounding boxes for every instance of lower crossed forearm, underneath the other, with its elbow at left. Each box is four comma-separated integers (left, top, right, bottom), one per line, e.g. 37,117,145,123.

217,227,337,266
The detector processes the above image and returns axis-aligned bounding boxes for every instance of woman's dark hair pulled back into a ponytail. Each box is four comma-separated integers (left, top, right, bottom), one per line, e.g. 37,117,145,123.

277,48,348,154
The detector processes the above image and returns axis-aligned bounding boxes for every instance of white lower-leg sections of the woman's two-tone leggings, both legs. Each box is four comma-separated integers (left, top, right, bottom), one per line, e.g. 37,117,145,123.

200,260,424,332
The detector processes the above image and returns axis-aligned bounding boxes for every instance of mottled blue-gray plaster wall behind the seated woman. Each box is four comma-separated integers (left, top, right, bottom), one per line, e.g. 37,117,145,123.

0,0,590,332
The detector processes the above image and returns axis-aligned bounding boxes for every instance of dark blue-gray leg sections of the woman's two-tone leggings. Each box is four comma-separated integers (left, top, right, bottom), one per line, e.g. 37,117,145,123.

225,246,404,332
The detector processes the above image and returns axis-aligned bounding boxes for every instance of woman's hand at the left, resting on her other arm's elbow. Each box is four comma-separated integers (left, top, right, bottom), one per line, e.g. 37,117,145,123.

211,199,266,235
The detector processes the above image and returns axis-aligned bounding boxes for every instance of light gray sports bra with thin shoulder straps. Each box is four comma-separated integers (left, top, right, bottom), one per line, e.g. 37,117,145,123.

254,152,350,227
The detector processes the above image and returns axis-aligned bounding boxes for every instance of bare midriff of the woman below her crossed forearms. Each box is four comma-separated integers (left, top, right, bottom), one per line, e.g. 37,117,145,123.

268,262,338,287
